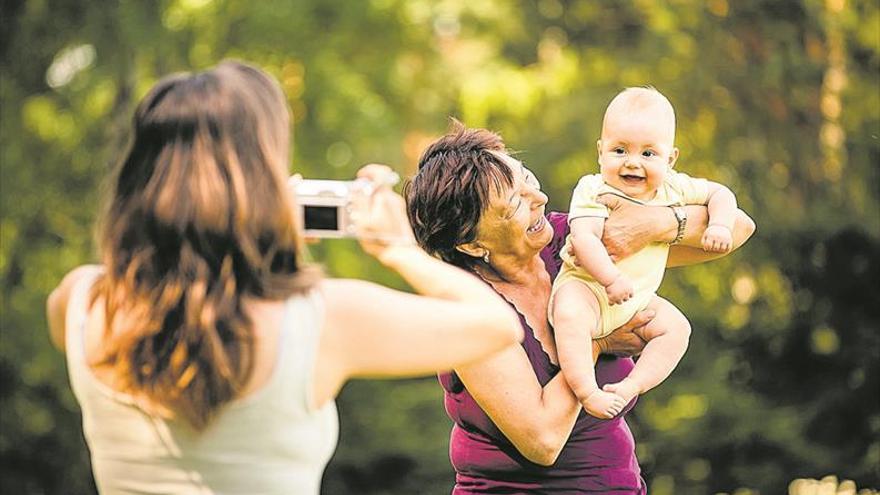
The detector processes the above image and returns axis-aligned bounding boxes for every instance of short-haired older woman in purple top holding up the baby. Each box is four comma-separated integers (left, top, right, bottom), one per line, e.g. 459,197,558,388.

406,124,754,494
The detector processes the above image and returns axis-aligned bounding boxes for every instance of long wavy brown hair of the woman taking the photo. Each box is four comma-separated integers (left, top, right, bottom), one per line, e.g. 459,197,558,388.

92,61,317,430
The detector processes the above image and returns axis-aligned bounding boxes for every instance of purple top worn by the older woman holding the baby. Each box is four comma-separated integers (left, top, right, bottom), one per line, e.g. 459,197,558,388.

440,213,647,495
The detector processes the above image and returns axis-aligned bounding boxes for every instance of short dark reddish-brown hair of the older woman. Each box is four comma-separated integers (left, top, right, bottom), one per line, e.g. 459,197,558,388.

404,119,513,269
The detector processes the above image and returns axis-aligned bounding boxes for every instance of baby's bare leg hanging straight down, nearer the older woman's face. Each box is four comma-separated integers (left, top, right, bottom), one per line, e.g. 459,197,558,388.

550,281,626,418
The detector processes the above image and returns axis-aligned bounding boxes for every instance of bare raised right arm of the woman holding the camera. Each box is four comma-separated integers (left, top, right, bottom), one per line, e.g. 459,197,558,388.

313,165,522,406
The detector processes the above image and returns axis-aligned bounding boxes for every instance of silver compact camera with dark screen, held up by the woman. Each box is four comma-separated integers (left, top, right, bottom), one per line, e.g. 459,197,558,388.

290,173,400,239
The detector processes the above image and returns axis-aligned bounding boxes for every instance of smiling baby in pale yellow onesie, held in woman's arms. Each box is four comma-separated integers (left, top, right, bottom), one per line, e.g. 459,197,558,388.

549,88,737,418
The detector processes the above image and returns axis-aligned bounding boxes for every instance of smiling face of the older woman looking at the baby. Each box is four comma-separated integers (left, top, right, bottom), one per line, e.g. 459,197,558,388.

476,153,553,261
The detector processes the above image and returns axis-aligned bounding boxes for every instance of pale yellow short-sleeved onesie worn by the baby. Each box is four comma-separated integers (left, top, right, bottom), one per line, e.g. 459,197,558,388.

550,170,709,338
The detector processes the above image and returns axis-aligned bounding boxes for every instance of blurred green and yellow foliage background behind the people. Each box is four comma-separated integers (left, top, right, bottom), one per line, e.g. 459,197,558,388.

0,0,880,495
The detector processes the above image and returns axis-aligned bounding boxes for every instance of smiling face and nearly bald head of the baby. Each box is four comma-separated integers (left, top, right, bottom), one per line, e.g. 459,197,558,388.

596,88,678,201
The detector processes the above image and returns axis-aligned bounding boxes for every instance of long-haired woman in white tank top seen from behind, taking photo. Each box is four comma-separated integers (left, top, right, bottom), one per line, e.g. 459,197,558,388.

47,62,522,494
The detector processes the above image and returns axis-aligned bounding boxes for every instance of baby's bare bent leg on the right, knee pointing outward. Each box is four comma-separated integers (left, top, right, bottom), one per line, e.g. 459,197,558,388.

603,296,691,403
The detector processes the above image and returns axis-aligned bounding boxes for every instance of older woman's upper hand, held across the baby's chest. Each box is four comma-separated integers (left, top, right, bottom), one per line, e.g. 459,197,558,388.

598,194,678,263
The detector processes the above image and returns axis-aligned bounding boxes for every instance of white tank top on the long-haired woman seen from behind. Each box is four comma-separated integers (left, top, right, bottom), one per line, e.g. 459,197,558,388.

66,280,339,495
